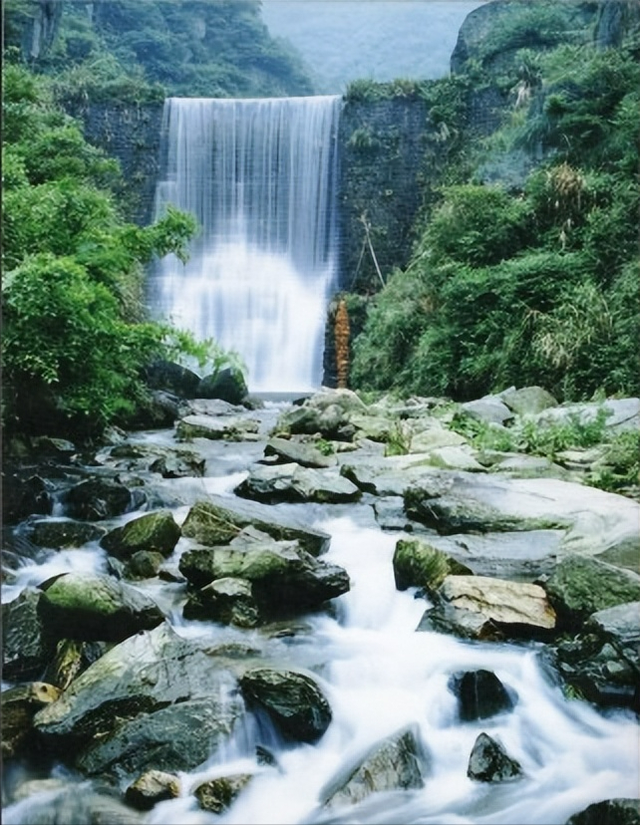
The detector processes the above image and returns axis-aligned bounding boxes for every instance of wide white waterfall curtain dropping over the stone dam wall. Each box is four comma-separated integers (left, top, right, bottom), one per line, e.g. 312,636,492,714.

149,95,341,392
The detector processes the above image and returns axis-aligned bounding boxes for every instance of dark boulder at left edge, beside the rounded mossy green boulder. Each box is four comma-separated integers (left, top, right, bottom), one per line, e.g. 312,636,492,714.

2,588,55,682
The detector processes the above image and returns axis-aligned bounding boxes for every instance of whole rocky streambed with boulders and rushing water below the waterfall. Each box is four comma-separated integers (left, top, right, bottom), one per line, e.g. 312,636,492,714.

2,388,640,825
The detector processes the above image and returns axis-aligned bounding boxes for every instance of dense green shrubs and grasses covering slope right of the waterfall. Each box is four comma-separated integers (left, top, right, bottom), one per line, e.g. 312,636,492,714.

351,8,640,400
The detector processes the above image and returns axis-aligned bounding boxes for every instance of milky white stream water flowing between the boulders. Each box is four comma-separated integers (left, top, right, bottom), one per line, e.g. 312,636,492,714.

3,404,639,825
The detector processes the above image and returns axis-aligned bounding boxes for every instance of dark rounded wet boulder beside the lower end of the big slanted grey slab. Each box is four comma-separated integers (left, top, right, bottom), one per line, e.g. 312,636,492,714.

240,668,332,743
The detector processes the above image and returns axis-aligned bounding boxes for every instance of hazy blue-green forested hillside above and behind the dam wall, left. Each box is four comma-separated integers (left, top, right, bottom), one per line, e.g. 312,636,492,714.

3,0,312,103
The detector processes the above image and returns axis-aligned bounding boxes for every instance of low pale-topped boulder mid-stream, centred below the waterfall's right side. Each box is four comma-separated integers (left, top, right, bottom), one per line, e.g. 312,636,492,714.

235,464,362,504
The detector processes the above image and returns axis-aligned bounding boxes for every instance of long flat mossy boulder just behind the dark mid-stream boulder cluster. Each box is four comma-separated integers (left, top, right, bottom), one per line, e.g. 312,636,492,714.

182,495,331,556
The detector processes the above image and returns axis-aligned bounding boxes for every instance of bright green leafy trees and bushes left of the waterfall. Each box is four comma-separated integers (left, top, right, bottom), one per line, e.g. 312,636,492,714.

2,63,202,435
